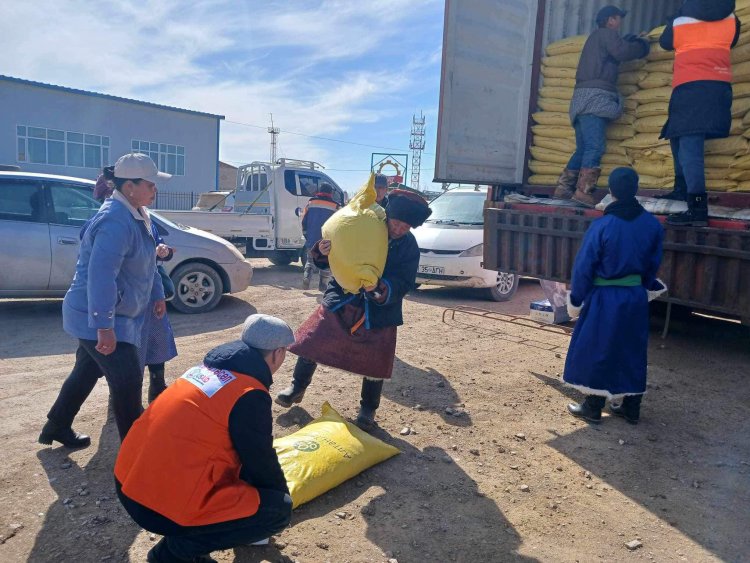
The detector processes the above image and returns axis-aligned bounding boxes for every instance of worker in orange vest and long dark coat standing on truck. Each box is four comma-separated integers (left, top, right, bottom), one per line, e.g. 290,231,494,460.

659,0,740,227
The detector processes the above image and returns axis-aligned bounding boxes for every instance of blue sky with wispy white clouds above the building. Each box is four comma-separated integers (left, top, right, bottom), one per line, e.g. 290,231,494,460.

0,0,443,194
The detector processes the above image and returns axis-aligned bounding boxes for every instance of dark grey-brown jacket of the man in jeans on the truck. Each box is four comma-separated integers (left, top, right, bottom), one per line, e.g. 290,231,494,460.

576,28,649,92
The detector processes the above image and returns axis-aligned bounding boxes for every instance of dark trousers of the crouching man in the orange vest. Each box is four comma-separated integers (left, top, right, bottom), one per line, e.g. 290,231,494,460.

115,480,292,562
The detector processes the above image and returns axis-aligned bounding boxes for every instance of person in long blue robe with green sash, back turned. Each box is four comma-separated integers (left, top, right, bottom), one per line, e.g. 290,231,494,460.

563,168,666,424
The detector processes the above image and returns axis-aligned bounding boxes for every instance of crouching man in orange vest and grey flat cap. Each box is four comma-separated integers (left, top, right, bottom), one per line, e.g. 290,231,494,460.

115,315,294,563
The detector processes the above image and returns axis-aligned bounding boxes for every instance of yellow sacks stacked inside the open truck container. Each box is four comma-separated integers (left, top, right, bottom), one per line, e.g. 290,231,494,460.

529,13,750,192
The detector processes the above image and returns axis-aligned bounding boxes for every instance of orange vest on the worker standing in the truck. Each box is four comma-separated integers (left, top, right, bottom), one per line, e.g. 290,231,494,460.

672,14,737,88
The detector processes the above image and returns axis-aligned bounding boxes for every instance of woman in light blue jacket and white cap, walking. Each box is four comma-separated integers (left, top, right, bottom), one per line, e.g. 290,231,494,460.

39,153,170,448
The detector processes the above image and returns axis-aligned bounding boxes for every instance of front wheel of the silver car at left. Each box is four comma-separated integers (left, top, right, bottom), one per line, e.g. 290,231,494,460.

170,262,224,313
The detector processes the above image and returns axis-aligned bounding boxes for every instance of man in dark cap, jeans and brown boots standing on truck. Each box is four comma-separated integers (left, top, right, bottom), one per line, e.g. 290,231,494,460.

555,6,649,207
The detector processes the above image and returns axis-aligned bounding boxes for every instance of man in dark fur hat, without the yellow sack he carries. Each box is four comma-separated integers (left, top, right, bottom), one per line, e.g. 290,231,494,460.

276,190,432,430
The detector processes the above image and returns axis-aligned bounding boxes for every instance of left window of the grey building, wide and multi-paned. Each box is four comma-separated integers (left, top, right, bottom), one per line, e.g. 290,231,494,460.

16,125,109,168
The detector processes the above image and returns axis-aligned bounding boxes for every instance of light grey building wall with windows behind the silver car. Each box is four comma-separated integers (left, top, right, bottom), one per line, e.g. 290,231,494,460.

0,80,220,192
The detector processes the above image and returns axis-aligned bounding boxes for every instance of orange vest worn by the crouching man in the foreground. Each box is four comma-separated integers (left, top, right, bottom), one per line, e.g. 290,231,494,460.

115,366,268,526
